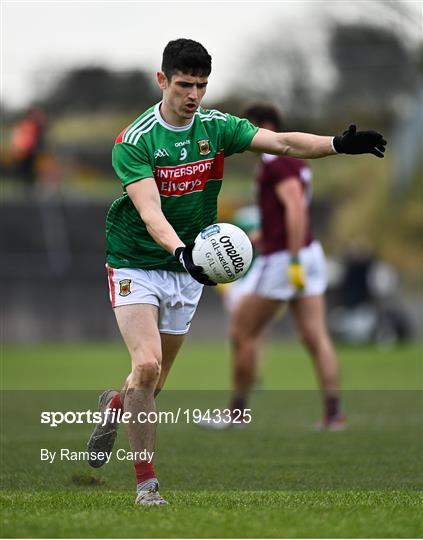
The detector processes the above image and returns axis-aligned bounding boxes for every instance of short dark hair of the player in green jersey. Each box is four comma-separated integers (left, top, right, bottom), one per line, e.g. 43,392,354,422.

162,38,211,81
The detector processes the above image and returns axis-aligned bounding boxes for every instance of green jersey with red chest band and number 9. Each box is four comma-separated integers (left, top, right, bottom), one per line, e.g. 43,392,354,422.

106,103,258,271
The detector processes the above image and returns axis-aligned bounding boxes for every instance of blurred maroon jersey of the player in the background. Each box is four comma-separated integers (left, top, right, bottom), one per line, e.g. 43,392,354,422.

256,154,313,255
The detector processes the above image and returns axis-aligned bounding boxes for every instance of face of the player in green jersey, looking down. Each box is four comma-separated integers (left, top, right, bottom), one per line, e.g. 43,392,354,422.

157,71,208,125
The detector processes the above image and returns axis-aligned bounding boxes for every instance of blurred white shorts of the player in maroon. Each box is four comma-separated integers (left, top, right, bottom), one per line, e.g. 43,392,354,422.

225,240,327,312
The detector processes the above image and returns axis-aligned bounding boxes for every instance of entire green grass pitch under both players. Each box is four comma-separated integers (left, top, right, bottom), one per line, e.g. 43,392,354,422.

0,342,423,538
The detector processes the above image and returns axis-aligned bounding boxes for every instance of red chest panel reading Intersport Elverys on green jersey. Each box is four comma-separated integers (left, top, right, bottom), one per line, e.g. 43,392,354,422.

154,150,225,197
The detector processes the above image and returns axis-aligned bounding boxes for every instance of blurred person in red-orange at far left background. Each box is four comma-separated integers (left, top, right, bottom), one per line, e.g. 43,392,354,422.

12,108,47,188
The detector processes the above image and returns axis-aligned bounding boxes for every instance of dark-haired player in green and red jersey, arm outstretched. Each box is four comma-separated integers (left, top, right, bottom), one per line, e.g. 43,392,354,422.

88,39,386,505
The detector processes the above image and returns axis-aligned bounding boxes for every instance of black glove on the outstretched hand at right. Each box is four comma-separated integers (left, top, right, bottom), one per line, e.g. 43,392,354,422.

333,124,386,157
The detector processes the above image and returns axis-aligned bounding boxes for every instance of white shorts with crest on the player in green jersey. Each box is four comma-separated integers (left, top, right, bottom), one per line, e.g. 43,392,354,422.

106,265,203,334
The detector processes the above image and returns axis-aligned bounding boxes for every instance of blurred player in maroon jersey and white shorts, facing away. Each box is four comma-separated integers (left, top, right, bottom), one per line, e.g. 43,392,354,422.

217,104,345,431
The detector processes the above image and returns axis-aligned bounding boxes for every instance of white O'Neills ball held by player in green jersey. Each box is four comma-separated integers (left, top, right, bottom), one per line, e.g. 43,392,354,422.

192,223,253,283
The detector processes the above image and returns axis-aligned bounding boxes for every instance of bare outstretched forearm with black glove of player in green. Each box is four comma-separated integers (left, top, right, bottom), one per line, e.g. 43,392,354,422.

249,124,386,159
